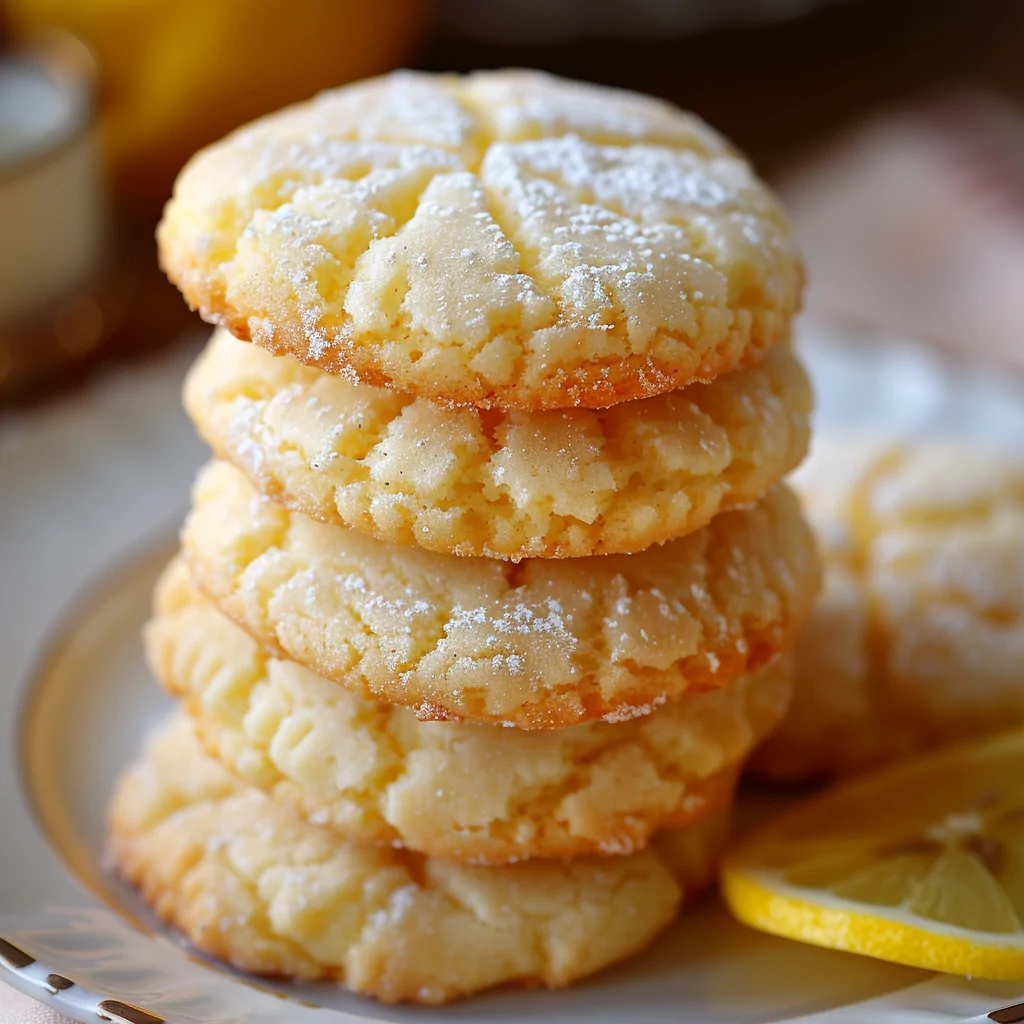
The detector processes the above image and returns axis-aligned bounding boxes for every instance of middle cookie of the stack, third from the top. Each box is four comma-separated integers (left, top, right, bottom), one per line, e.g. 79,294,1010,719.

182,463,818,729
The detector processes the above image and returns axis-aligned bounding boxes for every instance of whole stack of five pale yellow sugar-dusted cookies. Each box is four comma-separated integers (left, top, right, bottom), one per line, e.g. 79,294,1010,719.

111,73,818,1002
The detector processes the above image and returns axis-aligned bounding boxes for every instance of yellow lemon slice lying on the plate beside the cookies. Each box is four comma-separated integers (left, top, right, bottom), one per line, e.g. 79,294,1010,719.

722,732,1024,979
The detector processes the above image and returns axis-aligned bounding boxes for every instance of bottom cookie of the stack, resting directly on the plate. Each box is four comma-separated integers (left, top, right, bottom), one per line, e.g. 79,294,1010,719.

110,718,727,1004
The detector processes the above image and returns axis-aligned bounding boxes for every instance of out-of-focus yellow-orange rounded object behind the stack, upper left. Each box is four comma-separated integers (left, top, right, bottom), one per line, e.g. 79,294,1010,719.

7,0,424,205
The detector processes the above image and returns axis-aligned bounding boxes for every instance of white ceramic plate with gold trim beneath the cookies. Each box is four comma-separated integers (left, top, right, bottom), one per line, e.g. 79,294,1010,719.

0,332,1024,1024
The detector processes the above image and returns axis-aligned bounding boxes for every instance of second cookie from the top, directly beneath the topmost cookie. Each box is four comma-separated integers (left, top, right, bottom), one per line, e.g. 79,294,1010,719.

184,331,812,560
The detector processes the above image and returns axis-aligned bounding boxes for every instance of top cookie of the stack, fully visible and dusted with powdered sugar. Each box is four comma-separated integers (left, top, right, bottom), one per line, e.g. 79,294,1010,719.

158,72,803,410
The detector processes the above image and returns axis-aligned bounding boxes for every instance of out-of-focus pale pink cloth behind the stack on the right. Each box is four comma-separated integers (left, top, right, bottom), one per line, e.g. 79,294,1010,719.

780,95,1024,370
